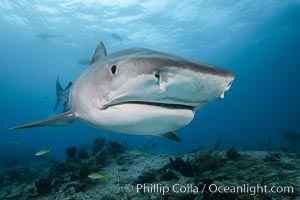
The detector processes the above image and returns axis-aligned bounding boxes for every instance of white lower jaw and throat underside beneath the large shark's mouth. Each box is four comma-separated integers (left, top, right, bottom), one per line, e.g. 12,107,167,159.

81,103,194,135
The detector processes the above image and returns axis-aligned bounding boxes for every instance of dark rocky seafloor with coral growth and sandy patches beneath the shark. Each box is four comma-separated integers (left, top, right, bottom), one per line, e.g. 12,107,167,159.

0,137,300,200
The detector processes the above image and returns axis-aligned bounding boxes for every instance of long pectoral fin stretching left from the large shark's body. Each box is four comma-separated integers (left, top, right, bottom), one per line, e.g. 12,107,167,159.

9,111,77,130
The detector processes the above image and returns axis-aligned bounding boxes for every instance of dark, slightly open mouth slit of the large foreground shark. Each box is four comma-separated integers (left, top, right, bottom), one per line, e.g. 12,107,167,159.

103,101,196,111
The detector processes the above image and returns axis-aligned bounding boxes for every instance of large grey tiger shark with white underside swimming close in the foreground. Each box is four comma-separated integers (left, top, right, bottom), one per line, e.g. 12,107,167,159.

10,42,235,141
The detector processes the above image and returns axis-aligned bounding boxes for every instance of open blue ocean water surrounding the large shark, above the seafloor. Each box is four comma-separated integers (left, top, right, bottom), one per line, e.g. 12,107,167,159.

0,0,300,160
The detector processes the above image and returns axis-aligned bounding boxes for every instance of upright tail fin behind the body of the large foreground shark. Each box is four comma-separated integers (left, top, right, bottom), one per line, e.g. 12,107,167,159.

53,76,72,112
